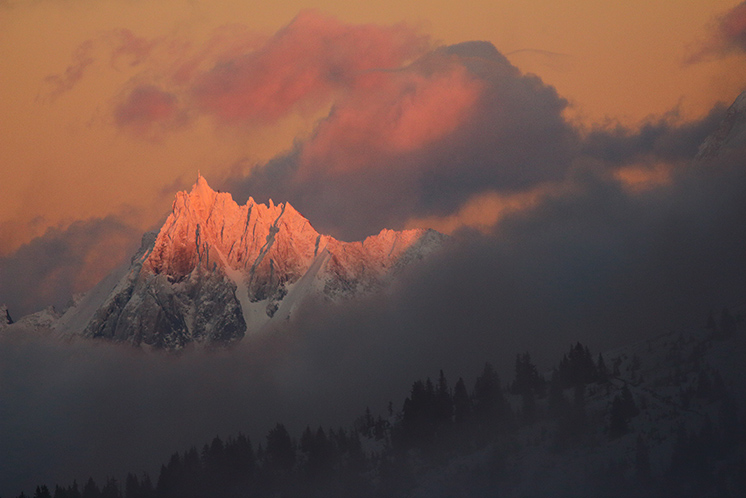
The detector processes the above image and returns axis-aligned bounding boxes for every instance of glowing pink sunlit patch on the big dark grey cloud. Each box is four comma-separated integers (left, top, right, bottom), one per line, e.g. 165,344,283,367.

301,61,484,175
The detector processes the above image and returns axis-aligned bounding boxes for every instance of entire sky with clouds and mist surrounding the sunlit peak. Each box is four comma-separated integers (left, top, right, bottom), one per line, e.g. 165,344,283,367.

0,0,746,495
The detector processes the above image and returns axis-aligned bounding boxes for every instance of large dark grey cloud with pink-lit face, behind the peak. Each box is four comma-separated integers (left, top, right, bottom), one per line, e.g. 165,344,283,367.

226,42,578,239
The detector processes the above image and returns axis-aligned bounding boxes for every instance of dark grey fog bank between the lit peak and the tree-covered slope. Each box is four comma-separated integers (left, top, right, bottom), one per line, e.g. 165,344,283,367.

5,108,746,494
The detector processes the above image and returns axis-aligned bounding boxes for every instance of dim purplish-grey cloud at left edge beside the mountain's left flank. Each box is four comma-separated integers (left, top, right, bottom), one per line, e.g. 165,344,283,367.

0,216,142,317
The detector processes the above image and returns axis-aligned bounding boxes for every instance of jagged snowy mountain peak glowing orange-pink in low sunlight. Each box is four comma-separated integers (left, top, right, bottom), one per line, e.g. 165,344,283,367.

54,176,444,349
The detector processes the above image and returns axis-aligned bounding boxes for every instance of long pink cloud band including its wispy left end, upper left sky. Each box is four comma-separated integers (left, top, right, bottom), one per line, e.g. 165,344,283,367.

46,10,432,139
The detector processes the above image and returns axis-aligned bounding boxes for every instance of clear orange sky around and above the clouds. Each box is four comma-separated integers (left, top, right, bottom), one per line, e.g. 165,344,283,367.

0,0,746,255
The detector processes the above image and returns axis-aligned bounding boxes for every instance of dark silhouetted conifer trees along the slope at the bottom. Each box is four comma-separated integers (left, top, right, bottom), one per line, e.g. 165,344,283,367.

8,310,746,498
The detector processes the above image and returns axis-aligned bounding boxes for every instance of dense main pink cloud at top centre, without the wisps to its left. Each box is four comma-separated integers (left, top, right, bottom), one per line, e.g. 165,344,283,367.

191,11,429,123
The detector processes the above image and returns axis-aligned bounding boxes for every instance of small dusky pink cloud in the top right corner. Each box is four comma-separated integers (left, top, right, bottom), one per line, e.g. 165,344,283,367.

686,2,746,63
